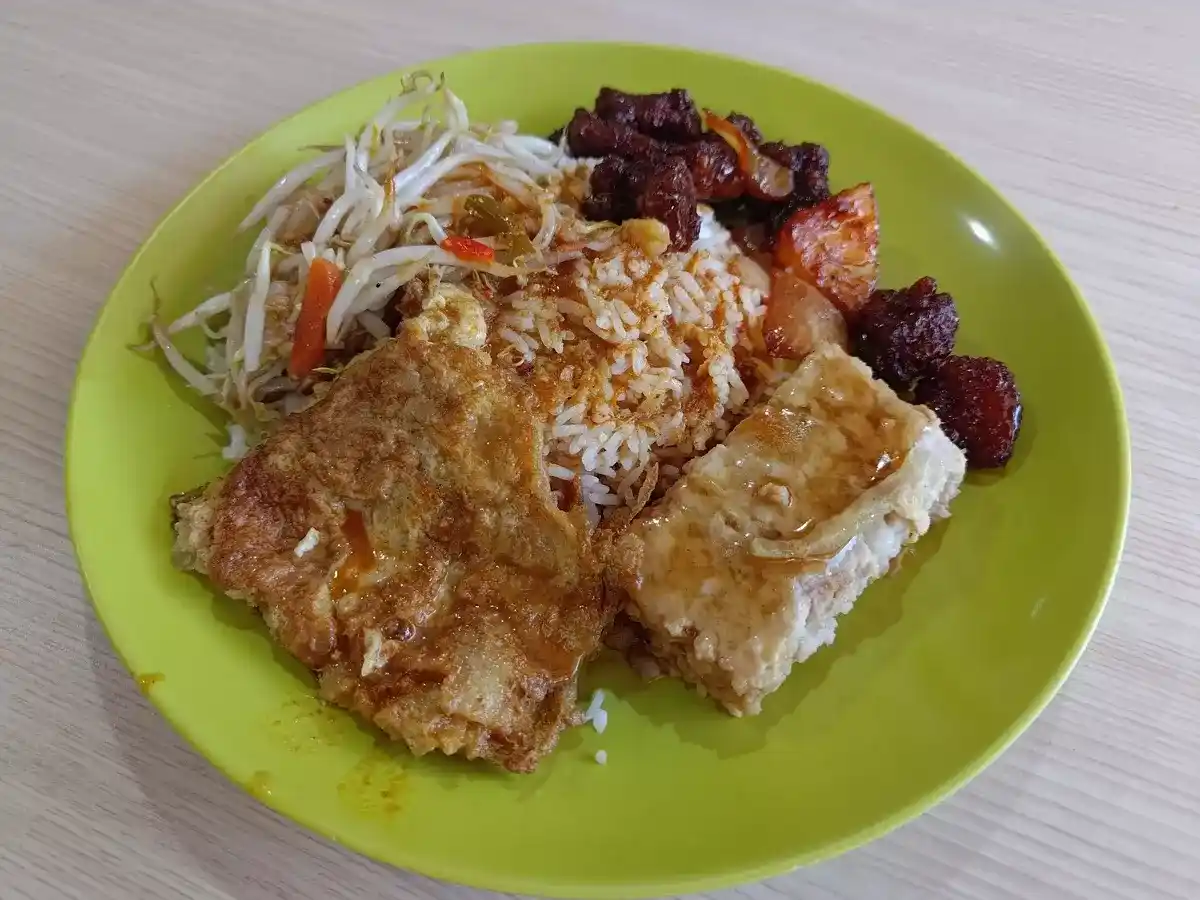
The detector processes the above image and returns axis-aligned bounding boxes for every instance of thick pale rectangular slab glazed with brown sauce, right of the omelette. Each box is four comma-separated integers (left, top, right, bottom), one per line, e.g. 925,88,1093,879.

610,344,965,715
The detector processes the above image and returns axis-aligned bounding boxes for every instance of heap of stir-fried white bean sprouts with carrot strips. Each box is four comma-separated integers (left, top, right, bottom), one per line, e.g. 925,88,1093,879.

141,73,576,457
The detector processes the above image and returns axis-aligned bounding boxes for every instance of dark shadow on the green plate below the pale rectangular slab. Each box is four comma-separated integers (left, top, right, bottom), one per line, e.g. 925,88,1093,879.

590,522,948,758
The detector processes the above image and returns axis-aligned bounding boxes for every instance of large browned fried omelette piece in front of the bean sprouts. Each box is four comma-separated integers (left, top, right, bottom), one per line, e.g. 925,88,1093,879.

175,324,613,772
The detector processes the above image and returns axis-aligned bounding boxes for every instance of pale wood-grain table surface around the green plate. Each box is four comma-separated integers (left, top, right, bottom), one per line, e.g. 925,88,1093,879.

0,0,1200,900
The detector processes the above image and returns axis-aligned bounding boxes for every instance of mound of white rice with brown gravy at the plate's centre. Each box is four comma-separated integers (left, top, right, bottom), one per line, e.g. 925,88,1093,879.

475,210,763,521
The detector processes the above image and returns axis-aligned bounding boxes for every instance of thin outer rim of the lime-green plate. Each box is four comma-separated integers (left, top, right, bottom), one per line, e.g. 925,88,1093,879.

62,41,1132,900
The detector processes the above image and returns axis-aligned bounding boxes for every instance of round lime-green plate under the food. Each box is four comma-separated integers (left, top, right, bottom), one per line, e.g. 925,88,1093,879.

67,44,1129,898
